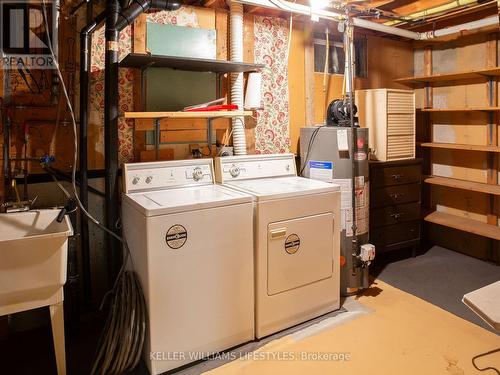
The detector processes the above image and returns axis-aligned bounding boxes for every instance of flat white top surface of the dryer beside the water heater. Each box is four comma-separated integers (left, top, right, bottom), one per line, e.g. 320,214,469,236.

225,176,340,200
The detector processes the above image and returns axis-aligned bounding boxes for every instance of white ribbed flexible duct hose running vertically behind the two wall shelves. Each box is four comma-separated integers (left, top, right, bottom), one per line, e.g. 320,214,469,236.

229,1,247,155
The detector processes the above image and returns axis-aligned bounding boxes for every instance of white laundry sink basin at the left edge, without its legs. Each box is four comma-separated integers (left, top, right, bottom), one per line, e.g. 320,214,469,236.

0,210,73,316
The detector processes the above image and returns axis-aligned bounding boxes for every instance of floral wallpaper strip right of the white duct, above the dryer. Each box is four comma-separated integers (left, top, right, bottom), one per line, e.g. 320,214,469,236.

254,16,290,154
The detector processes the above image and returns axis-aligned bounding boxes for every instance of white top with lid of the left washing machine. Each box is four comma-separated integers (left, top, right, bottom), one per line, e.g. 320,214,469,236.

123,185,252,216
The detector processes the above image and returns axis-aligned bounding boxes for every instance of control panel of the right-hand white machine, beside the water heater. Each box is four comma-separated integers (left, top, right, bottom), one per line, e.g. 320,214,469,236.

215,154,297,183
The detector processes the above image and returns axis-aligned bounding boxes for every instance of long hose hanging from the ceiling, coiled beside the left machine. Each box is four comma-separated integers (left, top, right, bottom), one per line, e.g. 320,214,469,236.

41,0,147,375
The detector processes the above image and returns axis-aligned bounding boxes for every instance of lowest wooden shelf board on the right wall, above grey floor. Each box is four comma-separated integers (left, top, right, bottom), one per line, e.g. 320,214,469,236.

424,211,500,240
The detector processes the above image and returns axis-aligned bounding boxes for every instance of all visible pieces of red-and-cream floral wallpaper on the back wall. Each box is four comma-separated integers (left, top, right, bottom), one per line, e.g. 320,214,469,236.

90,7,290,162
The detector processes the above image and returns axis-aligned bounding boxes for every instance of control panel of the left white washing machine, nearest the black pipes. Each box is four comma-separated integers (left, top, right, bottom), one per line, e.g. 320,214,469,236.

123,159,214,193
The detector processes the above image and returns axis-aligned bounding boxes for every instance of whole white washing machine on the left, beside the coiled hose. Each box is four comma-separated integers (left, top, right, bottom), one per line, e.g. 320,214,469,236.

122,159,254,375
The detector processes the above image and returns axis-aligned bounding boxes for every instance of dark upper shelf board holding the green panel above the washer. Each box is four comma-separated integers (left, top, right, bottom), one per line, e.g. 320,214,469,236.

120,53,264,73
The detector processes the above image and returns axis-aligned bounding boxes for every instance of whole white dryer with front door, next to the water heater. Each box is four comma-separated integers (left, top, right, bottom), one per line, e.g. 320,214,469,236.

215,154,340,338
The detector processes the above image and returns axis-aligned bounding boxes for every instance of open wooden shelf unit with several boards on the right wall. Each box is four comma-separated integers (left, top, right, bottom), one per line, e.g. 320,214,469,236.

395,39,500,245
